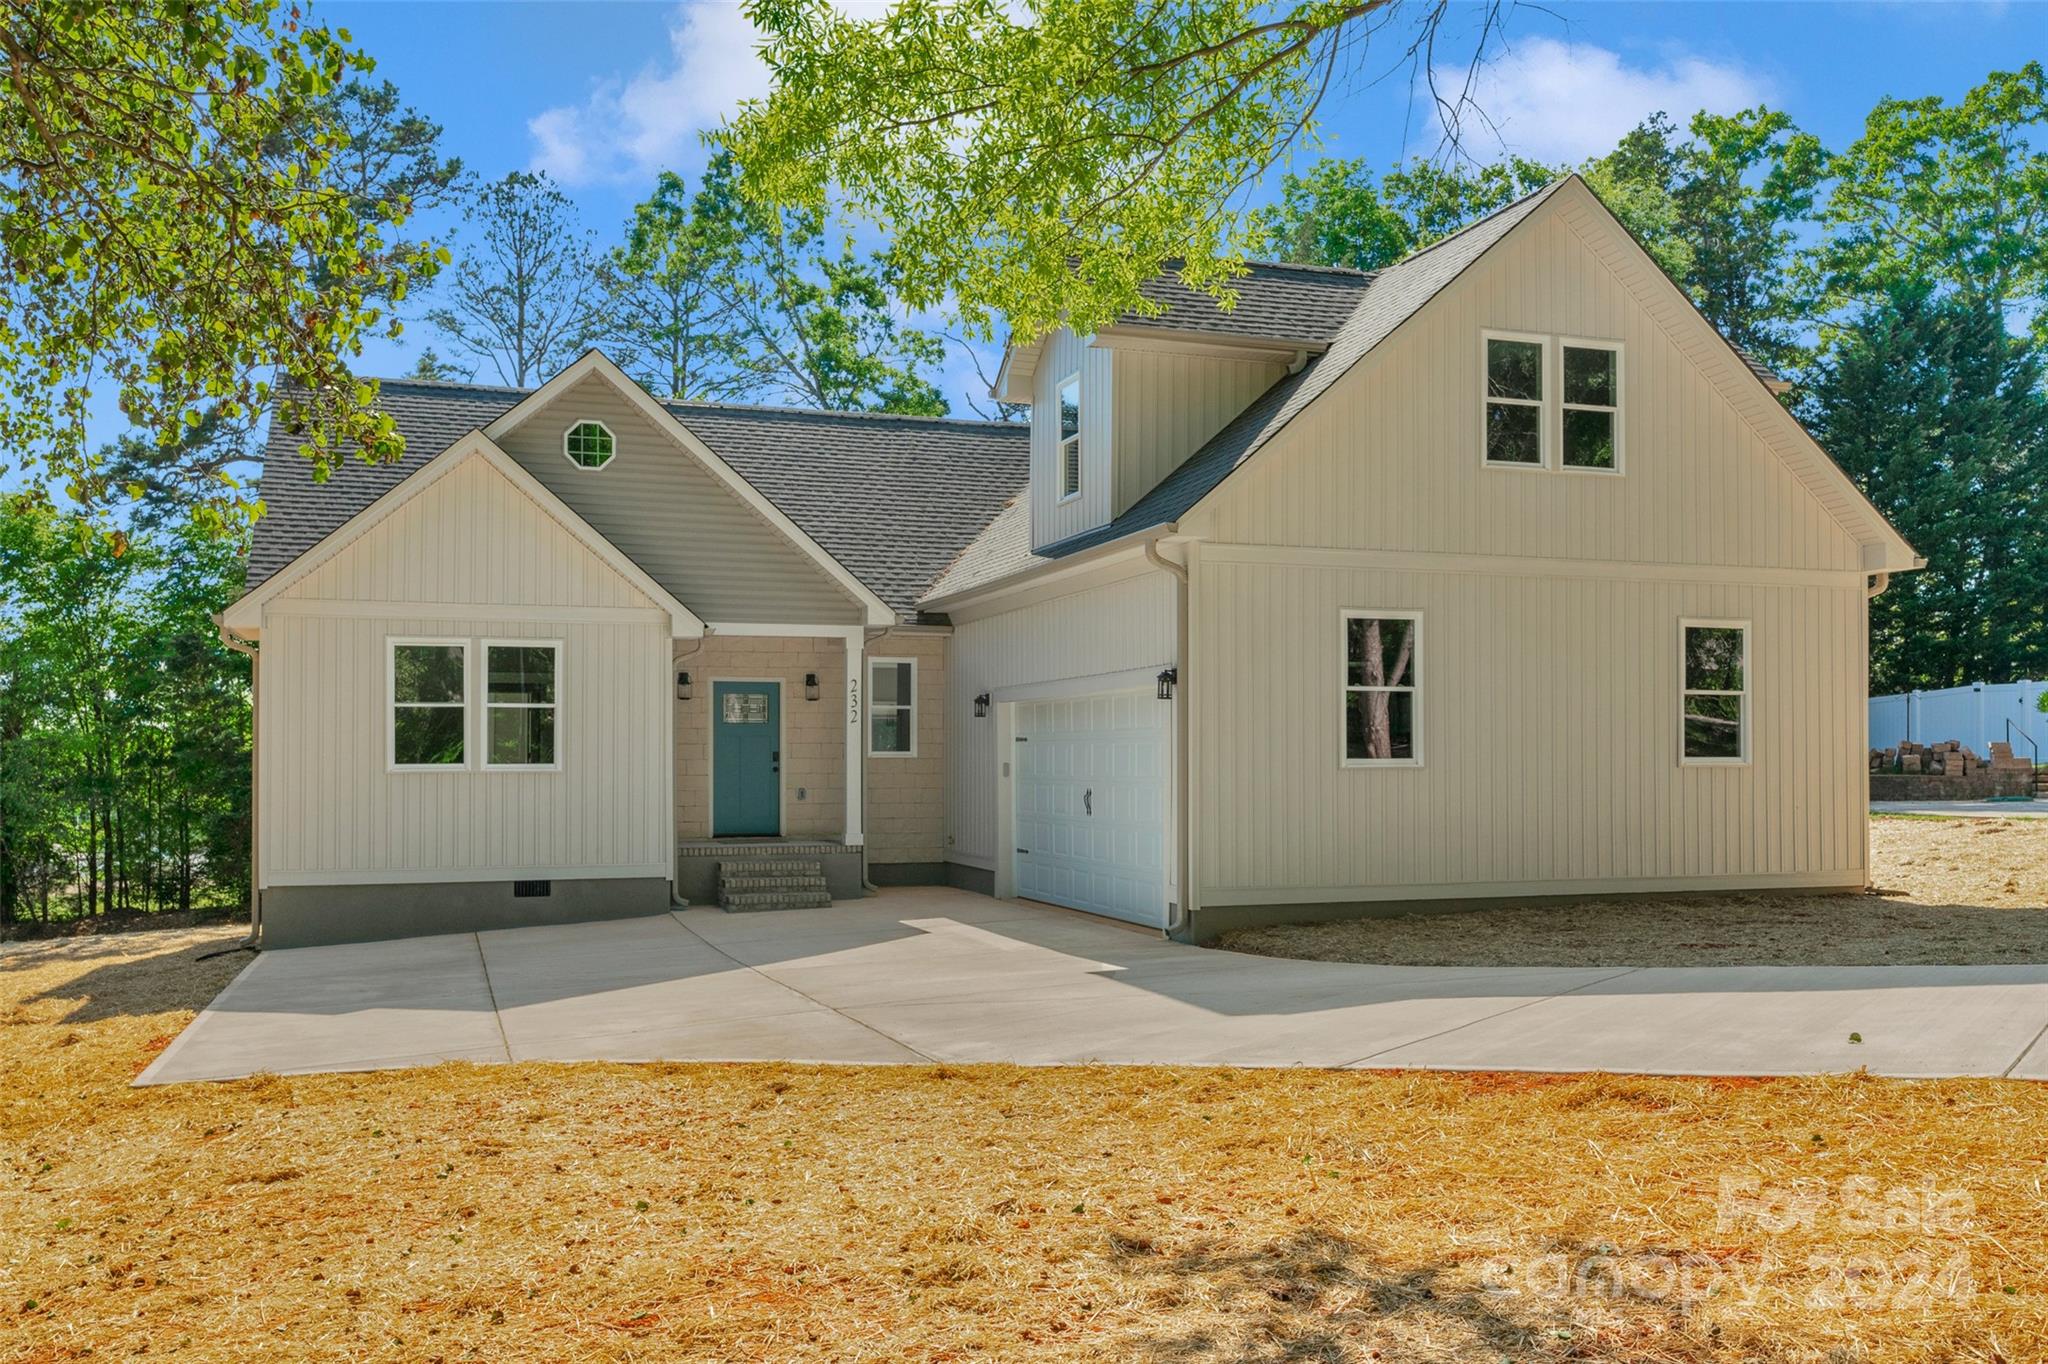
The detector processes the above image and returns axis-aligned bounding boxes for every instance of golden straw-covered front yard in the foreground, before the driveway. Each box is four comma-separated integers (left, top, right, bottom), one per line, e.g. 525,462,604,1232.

0,930,2048,1364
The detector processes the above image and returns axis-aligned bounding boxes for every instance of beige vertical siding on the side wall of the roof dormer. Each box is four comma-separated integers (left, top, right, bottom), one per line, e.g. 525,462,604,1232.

1110,340,1286,516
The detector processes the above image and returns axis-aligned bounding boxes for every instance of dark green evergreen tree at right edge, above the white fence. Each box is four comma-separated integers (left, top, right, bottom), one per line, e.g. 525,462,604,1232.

1806,281,2048,692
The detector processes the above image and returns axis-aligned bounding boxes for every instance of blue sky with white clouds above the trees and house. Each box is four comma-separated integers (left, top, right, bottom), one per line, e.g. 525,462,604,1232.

313,0,2048,410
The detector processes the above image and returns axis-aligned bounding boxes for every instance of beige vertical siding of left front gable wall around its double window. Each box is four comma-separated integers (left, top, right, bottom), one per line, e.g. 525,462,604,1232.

258,457,670,885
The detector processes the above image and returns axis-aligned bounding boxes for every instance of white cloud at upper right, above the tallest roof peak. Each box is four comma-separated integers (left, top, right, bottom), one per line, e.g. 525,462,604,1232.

1462,37,1769,162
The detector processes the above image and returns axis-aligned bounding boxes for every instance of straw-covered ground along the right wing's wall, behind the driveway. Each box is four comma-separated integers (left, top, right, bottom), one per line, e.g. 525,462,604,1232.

1217,817,2048,967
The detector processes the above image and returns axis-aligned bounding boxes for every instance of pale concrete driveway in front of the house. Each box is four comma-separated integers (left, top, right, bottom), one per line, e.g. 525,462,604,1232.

135,889,2048,1085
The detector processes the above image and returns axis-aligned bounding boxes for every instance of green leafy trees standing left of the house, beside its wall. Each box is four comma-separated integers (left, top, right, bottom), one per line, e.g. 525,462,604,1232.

0,498,250,922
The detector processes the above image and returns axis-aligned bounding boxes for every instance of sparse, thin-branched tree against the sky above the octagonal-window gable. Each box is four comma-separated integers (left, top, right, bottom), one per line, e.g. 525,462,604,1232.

426,170,604,387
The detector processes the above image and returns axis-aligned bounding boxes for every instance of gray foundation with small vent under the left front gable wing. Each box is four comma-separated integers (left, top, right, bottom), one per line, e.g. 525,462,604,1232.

262,877,670,948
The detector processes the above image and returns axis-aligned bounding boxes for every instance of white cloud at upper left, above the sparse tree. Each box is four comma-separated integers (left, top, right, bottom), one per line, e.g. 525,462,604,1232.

526,0,768,184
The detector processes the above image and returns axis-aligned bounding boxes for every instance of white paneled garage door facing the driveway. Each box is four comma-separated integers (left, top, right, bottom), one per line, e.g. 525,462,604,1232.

1014,692,1174,928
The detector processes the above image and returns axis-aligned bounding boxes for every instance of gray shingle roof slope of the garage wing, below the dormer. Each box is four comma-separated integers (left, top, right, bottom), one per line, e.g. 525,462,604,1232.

928,180,1565,600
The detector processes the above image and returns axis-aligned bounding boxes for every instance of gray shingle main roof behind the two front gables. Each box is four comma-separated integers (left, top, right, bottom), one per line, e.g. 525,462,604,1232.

248,379,1030,614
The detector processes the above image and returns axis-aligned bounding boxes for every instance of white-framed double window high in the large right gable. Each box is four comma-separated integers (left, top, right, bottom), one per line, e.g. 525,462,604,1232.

1481,332,1622,473
